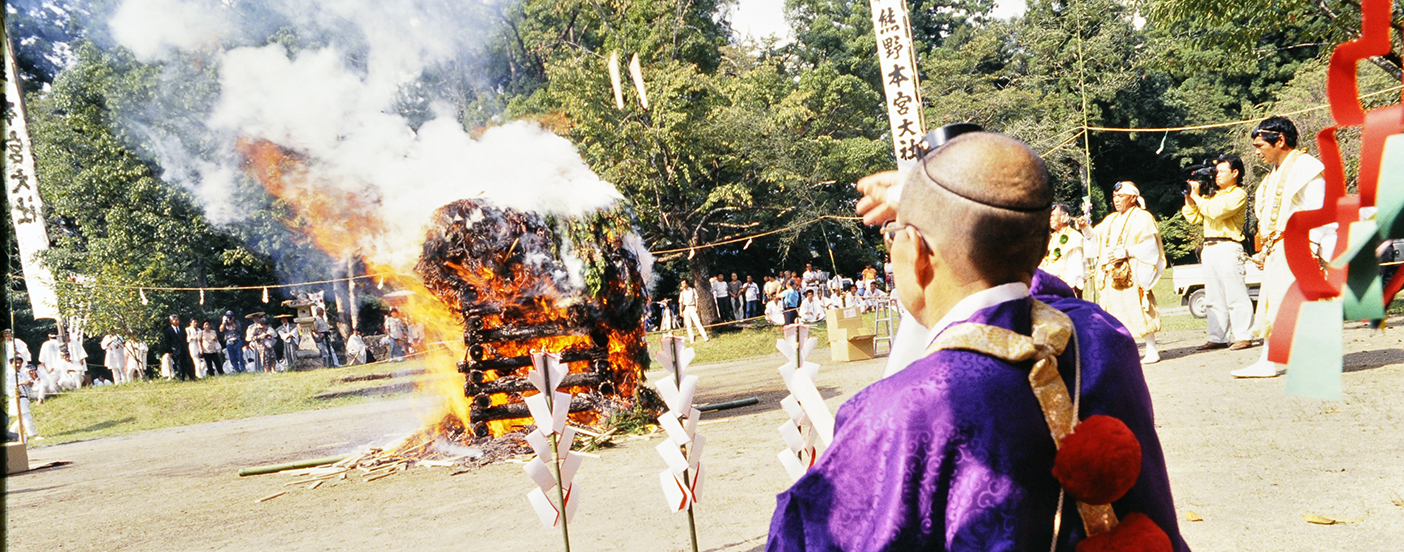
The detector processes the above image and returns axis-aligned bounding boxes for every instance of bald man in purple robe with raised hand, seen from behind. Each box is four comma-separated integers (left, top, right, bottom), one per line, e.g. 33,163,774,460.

767,125,1185,551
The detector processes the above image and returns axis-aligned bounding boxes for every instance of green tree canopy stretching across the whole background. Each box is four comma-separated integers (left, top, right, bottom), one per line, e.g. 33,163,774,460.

6,0,1400,336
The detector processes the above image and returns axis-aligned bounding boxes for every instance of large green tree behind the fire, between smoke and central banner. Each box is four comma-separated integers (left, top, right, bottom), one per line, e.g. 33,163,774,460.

508,1,890,323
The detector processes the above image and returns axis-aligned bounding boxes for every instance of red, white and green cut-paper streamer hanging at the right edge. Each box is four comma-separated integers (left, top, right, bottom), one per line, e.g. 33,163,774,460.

1268,0,1404,399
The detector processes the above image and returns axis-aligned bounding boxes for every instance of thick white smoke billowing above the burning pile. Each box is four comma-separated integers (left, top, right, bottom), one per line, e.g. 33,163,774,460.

112,0,647,275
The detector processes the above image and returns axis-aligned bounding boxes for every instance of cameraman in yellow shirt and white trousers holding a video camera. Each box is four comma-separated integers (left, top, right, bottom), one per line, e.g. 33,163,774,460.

1179,155,1252,351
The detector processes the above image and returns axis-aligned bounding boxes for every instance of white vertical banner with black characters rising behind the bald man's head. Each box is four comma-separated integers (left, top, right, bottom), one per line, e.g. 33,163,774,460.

869,0,927,171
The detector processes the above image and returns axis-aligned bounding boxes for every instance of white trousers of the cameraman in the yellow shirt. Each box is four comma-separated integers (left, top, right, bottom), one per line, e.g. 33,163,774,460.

1200,242,1252,343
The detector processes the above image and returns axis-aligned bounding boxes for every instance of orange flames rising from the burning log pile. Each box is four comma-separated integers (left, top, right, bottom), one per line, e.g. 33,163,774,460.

236,139,644,437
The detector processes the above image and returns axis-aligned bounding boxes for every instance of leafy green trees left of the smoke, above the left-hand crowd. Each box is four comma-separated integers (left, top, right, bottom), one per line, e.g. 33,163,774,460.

29,44,271,341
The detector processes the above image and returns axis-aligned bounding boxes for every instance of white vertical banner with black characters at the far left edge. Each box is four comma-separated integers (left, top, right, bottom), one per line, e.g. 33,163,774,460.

4,37,59,320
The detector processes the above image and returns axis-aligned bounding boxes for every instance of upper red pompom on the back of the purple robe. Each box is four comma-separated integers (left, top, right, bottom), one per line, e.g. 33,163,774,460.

1053,414,1140,504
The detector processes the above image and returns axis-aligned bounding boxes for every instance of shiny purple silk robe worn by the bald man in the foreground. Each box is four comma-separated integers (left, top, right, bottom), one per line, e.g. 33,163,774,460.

767,271,1189,552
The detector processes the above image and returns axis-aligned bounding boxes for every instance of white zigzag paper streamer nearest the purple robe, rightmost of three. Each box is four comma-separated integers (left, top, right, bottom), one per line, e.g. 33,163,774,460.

775,323,834,480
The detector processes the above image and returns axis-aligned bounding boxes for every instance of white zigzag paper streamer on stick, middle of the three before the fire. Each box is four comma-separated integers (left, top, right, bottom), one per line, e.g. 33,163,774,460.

657,334,706,551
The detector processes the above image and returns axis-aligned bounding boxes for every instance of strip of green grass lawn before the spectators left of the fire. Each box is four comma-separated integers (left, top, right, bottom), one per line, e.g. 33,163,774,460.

21,360,423,445
